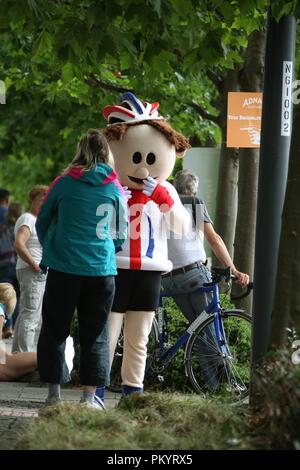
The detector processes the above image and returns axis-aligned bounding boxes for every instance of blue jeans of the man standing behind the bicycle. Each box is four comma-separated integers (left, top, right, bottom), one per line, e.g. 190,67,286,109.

162,265,222,389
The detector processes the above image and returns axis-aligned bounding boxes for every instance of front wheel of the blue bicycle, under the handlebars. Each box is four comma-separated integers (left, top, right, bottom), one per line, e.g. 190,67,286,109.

185,310,251,401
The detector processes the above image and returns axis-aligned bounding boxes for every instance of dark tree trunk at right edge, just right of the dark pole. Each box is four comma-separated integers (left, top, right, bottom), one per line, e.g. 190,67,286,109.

270,104,300,347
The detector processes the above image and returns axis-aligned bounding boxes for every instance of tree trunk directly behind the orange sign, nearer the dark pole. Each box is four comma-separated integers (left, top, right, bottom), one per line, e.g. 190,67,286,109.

233,30,266,312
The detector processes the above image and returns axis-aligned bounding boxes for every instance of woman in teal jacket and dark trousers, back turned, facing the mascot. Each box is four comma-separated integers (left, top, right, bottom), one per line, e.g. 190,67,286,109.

36,129,127,408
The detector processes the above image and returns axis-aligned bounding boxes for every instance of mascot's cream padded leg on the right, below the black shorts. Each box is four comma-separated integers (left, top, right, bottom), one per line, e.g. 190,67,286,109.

121,310,154,389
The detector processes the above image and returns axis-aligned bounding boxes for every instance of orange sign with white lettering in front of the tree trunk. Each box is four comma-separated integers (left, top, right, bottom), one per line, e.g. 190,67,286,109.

227,92,262,148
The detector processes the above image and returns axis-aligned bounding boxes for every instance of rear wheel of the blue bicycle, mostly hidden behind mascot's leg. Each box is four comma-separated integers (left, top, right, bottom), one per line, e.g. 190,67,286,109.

106,318,158,393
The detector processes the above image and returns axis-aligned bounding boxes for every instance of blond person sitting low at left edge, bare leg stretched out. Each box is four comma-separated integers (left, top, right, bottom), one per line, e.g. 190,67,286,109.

0,283,37,381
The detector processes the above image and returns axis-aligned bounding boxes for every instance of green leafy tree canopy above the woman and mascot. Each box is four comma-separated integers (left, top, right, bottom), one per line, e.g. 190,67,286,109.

0,0,266,198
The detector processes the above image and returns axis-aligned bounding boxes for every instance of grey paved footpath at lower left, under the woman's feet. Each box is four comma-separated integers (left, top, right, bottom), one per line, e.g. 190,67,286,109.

0,340,120,450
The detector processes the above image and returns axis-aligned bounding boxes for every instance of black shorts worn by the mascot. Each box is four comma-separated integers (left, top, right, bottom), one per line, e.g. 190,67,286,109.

112,269,161,313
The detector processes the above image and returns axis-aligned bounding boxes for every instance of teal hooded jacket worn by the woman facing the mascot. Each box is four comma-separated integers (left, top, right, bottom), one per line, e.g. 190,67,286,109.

36,163,127,276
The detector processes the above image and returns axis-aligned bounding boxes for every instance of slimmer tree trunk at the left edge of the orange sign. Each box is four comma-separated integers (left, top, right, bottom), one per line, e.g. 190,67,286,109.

213,69,239,266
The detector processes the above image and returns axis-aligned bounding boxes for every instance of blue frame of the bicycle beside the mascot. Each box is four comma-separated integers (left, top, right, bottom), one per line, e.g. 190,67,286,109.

158,284,230,368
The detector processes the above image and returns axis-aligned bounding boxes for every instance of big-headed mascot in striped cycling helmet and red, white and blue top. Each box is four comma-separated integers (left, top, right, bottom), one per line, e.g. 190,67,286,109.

100,92,189,395
